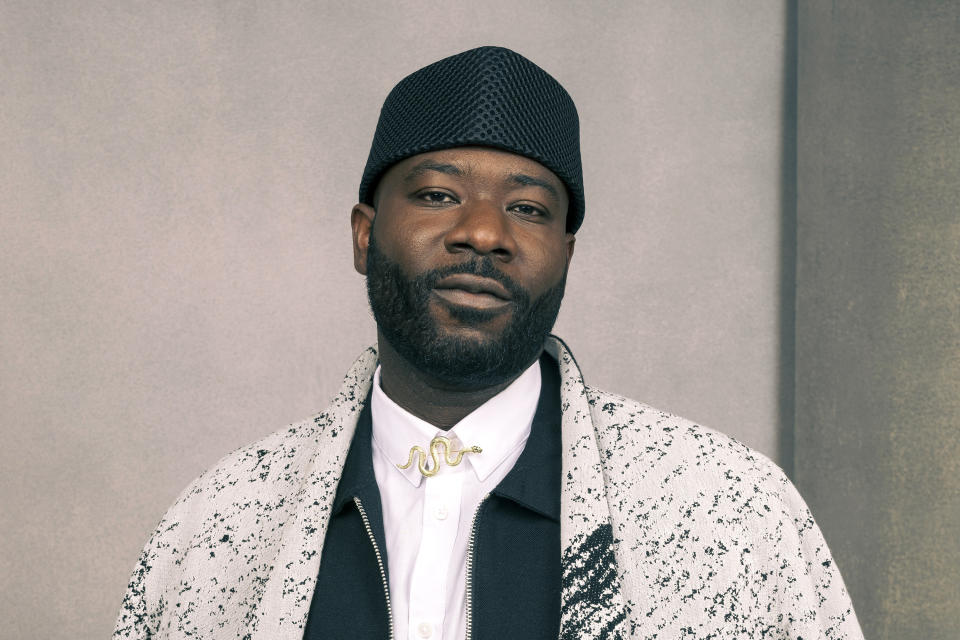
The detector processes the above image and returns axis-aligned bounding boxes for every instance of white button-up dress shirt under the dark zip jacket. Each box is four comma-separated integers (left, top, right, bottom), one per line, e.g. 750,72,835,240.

370,362,540,640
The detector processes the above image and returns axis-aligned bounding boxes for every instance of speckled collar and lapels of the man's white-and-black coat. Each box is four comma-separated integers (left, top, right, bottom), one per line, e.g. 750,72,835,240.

250,336,627,640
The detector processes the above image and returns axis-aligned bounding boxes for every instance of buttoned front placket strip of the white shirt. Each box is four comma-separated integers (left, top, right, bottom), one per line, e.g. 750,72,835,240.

407,466,465,640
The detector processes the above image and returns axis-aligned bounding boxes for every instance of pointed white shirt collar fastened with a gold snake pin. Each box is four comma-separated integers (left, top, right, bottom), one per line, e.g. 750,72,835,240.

370,361,541,487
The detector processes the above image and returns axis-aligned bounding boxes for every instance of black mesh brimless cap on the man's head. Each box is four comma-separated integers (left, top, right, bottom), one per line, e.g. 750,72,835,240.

360,47,584,232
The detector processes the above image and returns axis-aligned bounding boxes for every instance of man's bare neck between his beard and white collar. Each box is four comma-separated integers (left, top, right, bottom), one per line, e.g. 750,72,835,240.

377,332,525,430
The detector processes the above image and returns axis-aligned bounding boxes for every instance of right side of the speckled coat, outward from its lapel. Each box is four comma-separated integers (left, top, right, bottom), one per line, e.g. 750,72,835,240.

587,389,862,639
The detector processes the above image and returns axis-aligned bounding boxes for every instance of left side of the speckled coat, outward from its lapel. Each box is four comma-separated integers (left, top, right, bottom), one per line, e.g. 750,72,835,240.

114,413,349,638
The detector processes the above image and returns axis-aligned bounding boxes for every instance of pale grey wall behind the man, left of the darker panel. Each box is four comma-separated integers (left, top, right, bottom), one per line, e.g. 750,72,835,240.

0,0,956,638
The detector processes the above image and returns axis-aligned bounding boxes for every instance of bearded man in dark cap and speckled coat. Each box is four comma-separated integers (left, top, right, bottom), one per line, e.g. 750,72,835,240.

115,47,862,640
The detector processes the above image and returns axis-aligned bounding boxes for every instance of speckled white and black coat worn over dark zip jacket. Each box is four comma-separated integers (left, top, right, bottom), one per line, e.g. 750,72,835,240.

114,337,863,640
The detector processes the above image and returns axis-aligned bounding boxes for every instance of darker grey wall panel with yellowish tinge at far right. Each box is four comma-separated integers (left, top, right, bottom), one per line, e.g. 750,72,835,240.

795,1,960,640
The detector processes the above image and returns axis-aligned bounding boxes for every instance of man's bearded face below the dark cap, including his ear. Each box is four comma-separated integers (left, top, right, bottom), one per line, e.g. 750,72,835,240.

352,147,574,388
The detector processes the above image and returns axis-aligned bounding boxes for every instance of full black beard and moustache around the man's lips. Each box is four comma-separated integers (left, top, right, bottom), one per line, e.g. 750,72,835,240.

367,230,567,389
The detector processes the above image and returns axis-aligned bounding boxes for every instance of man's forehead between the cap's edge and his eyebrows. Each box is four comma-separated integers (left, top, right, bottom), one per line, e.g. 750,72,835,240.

384,147,566,191
